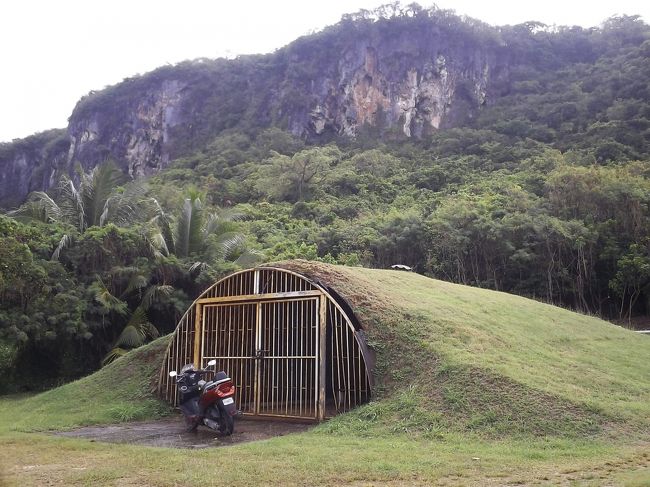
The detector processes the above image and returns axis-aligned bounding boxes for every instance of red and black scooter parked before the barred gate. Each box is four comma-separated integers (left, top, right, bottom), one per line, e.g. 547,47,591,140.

169,360,238,436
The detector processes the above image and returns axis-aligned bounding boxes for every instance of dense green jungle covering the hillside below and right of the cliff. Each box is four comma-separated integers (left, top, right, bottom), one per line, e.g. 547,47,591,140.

0,7,650,392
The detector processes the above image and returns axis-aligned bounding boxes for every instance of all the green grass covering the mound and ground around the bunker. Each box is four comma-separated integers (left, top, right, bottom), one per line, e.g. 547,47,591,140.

0,262,650,486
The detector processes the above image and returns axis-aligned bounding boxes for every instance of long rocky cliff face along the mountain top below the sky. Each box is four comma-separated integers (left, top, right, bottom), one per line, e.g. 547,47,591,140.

0,11,507,206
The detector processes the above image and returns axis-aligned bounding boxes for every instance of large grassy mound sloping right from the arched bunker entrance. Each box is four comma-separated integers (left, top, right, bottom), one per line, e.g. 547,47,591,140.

278,261,650,438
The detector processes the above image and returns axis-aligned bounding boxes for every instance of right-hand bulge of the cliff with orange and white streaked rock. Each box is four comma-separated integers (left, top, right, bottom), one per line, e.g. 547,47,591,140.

285,20,507,138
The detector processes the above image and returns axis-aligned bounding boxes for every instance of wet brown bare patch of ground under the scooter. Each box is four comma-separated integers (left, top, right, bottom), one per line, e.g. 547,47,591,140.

56,415,313,448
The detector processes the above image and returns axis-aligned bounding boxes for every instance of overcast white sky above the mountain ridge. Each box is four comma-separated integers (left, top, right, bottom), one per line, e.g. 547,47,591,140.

0,0,650,141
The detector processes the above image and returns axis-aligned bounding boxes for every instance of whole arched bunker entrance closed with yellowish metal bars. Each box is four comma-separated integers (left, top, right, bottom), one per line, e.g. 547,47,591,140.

159,267,372,420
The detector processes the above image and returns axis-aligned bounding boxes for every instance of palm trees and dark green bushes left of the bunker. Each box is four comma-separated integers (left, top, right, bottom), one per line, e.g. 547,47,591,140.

0,164,258,390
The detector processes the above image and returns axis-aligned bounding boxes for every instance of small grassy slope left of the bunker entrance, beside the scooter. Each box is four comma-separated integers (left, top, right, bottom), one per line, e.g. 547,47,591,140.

0,336,170,431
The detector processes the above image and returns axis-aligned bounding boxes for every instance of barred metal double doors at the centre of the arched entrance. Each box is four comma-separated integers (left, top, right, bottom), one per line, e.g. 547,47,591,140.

195,296,321,419
